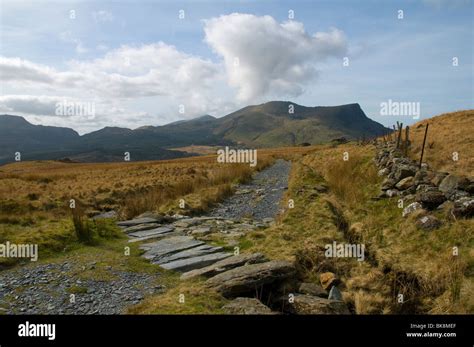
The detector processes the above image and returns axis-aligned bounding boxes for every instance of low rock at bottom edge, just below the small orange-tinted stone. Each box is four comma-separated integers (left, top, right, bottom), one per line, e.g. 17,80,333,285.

284,294,350,314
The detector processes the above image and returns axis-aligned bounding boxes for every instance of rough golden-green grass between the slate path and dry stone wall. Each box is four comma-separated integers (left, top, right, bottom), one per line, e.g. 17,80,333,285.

241,144,474,314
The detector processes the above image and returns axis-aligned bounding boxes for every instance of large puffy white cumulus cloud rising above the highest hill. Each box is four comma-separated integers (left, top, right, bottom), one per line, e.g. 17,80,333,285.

204,13,347,102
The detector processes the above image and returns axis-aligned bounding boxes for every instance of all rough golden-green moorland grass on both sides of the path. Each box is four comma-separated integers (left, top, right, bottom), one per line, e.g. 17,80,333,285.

0,111,474,314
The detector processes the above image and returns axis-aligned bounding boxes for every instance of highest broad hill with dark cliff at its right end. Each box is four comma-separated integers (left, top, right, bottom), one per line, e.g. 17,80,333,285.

216,101,386,147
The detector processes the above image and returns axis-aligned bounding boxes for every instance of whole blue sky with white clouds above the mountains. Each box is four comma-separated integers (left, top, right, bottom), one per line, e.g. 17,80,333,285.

0,0,474,134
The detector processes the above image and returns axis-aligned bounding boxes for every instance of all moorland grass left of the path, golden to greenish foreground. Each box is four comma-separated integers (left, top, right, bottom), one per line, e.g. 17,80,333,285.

0,147,309,266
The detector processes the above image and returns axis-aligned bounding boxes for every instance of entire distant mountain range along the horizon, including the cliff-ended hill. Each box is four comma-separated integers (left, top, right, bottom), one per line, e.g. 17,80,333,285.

0,101,387,163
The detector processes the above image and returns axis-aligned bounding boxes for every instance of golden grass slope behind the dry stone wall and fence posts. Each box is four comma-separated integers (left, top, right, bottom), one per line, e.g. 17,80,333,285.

410,110,474,176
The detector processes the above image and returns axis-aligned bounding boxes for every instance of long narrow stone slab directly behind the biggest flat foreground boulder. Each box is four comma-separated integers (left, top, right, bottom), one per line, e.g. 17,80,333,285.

181,253,267,280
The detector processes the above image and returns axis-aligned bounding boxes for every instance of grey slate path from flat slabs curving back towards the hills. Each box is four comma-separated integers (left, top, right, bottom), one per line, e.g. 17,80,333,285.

122,159,291,278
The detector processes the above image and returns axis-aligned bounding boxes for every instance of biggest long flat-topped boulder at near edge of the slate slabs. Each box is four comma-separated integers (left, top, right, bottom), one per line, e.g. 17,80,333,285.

206,260,296,297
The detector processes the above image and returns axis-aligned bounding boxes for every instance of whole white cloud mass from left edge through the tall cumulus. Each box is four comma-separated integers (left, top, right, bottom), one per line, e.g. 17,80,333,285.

0,12,347,131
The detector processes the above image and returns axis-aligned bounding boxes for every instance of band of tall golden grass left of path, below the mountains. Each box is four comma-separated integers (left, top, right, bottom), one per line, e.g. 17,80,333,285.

0,147,311,217
